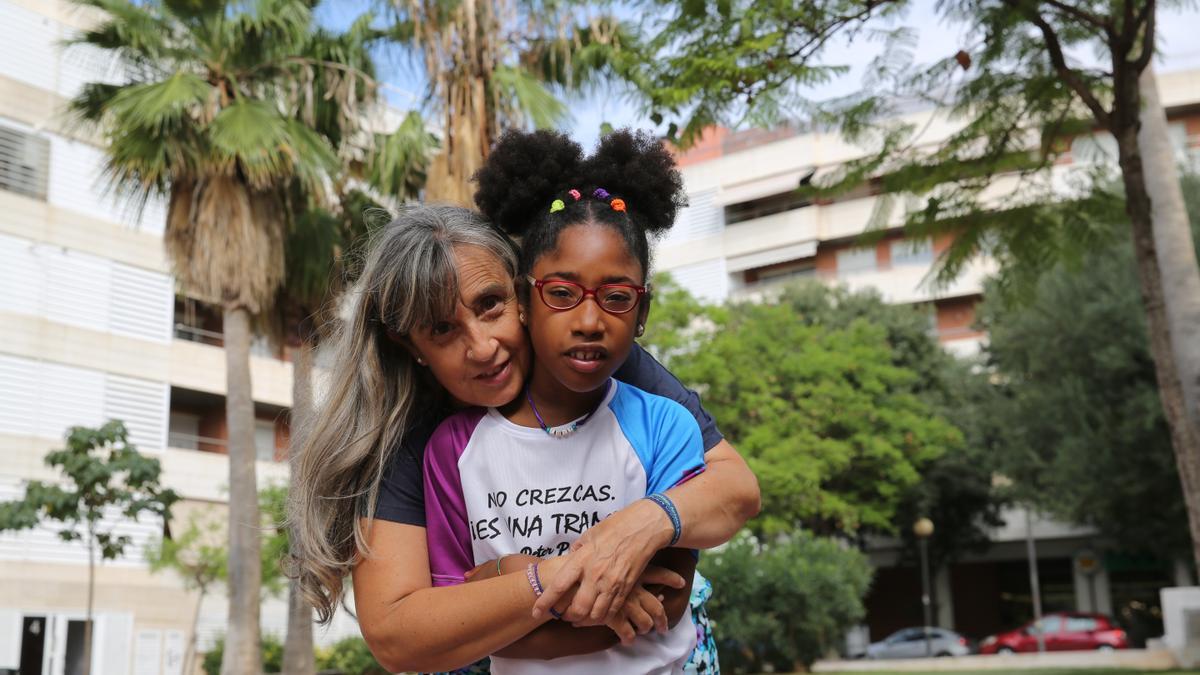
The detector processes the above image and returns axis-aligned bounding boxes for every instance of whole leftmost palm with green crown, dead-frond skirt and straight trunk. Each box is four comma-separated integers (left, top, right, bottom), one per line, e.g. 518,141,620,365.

64,0,365,674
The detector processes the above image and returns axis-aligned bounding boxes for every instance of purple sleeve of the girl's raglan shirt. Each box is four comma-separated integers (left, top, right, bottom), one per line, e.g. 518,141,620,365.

425,408,486,586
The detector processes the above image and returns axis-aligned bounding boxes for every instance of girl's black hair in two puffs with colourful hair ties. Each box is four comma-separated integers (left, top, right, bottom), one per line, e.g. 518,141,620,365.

475,130,686,276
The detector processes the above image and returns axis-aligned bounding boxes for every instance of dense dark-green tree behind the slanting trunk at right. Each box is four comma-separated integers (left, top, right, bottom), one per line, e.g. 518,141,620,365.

980,177,1200,558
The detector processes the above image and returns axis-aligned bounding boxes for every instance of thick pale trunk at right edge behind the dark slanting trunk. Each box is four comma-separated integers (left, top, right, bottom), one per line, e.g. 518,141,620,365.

1114,68,1200,565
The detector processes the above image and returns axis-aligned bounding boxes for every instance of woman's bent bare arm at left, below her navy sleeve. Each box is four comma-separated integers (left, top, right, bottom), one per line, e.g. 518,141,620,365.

353,520,690,673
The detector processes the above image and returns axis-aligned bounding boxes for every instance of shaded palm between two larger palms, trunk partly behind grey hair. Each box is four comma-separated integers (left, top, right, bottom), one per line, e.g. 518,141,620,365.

262,22,436,675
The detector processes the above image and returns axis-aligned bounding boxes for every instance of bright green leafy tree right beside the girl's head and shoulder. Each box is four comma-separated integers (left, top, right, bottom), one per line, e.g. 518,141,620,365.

646,277,962,533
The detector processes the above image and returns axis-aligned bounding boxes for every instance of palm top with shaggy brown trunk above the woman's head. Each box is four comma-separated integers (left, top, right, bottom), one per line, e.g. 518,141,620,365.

391,0,632,200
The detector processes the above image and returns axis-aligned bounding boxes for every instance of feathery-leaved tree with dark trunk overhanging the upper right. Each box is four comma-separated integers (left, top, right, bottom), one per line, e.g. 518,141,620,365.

637,0,1200,562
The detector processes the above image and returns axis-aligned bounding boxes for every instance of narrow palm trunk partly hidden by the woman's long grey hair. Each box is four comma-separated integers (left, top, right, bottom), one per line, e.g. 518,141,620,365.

283,340,317,675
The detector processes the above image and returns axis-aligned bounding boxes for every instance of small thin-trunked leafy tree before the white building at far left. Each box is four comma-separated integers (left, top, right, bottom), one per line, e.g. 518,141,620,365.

0,420,179,675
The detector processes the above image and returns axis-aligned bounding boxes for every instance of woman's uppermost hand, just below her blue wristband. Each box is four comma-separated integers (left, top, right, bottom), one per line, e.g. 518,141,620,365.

533,500,684,626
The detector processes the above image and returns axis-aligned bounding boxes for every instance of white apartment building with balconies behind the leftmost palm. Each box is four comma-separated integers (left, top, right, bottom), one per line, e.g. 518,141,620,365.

0,0,358,675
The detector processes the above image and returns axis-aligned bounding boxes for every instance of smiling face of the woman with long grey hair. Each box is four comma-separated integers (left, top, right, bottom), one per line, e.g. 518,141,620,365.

408,246,529,406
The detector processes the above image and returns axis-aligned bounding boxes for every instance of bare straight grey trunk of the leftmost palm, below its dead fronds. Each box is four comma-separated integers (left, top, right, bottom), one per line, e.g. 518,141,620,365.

221,306,263,675
